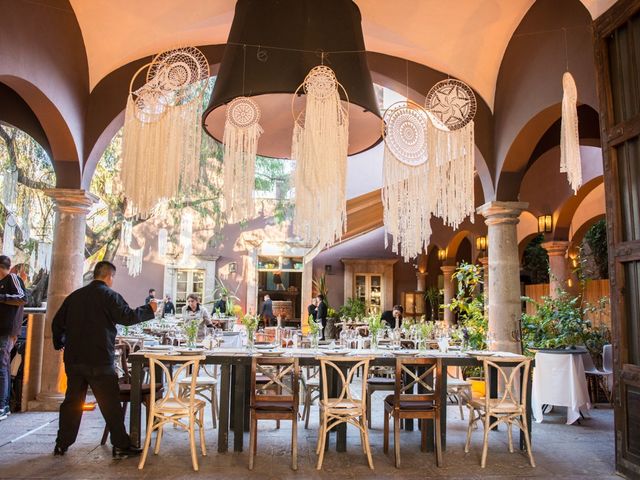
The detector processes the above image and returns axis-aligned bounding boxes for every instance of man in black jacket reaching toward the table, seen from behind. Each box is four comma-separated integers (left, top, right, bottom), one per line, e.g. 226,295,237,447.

52,261,157,457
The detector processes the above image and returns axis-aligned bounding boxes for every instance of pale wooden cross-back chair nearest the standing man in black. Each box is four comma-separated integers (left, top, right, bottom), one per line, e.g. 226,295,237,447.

138,354,207,471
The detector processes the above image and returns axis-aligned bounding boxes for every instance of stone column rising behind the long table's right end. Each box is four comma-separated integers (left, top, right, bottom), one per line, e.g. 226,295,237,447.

477,201,528,353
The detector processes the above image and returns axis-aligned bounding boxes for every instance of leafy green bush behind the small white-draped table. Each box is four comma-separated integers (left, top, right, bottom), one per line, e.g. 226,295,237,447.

522,290,611,359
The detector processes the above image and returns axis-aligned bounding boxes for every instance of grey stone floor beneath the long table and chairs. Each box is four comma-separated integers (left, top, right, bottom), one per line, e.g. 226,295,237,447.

0,402,619,480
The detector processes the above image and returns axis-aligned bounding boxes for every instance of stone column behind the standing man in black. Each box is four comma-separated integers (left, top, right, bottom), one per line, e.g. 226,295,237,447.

29,188,98,411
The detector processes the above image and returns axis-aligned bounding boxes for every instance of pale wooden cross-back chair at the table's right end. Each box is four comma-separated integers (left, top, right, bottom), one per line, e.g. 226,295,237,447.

464,357,536,468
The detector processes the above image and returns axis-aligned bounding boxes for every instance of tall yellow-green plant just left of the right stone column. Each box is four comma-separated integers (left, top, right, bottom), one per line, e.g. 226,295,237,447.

444,262,488,349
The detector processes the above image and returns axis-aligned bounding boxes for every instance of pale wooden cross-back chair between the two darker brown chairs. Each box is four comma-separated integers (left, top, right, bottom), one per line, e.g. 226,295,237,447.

316,356,373,470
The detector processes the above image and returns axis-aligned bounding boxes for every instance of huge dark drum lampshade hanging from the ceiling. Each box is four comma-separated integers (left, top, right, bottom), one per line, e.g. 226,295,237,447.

203,0,381,158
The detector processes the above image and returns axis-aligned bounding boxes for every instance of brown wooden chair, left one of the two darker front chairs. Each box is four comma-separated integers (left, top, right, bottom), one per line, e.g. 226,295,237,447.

249,357,300,470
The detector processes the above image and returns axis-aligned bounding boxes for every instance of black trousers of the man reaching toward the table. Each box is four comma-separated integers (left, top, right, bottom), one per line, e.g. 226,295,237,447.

56,365,131,448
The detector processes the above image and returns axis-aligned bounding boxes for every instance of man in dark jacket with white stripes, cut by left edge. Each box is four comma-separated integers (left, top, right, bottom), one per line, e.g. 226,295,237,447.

0,255,26,420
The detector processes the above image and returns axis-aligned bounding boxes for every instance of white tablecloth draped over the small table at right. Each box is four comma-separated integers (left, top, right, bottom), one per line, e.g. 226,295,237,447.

531,353,591,425
